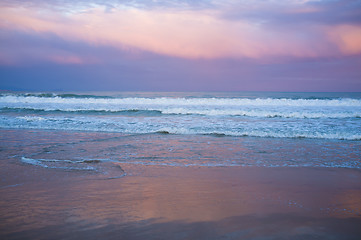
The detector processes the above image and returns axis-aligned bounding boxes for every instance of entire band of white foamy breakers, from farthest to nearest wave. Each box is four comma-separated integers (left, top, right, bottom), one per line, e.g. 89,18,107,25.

0,94,361,140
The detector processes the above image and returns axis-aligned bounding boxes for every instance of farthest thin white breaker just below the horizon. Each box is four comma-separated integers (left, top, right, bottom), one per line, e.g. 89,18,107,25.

0,94,361,107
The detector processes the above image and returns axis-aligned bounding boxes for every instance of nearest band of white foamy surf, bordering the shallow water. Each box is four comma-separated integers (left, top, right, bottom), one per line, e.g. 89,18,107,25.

0,115,361,140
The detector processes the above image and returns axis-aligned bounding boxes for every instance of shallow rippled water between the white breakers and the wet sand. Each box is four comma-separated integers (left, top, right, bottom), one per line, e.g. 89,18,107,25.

1,130,361,171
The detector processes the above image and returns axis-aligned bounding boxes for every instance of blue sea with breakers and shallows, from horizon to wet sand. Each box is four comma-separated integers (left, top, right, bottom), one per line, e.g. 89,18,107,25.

0,92,361,171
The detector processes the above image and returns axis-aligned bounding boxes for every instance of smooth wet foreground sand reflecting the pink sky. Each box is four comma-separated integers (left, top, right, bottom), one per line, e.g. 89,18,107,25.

1,164,361,239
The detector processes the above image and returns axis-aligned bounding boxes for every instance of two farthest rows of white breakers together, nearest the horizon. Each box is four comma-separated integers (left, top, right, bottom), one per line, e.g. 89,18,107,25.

0,94,361,118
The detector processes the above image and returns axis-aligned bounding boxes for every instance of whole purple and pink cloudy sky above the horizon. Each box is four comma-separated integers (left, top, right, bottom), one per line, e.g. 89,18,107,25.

0,0,361,92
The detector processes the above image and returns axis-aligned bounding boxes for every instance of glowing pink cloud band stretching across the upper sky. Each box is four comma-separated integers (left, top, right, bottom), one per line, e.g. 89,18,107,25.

0,3,361,60
